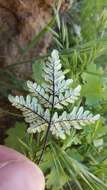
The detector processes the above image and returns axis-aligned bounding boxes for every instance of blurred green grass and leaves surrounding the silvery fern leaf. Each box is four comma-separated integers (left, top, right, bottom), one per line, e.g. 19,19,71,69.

0,0,107,190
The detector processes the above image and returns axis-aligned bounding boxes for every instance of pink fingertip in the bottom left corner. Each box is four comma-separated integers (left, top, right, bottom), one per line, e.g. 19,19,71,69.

0,146,45,190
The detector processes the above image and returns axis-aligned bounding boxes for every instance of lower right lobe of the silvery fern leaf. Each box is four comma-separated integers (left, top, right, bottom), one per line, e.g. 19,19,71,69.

50,107,100,139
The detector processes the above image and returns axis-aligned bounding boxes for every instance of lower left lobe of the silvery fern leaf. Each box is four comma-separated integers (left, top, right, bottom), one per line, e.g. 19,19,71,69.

9,95,50,132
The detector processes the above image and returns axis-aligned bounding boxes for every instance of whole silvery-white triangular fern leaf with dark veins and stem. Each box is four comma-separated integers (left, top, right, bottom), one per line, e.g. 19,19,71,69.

9,50,100,162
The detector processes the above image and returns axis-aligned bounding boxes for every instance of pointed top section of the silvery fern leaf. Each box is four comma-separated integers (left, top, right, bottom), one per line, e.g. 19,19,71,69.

43,50,73,95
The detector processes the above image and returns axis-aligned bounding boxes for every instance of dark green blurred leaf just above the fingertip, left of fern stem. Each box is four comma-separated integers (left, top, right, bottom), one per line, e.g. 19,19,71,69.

5,122,39,162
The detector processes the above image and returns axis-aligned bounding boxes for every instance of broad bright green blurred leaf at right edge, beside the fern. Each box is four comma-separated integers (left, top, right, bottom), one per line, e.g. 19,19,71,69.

82,64,107,106
